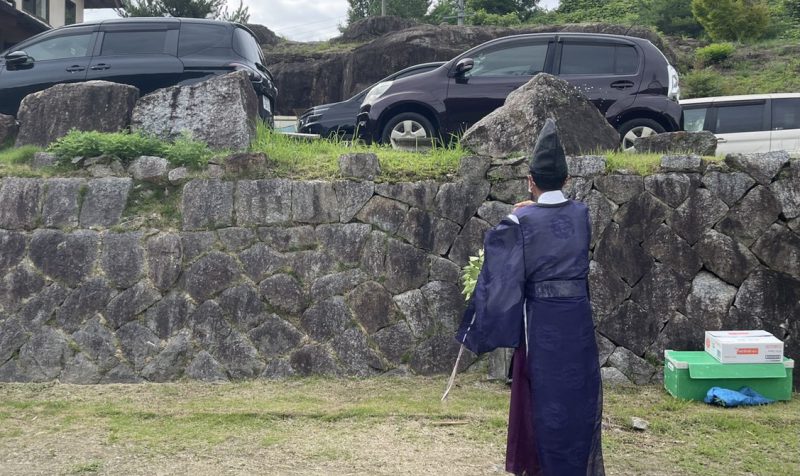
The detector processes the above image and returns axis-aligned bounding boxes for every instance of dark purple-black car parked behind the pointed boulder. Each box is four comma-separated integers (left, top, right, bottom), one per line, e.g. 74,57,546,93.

357,33,681,149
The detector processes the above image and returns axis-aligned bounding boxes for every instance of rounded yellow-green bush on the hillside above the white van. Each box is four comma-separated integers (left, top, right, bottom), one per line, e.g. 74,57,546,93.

692,0,769,41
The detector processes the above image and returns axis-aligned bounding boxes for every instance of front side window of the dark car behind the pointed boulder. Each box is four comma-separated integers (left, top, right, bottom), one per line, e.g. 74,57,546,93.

465,43,547,77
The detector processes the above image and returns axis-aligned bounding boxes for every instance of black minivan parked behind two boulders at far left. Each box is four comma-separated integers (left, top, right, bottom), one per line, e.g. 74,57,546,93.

0,18,278,124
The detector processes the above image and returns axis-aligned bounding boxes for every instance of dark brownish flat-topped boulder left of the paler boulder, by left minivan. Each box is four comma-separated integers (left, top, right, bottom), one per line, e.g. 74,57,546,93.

17,81,139,147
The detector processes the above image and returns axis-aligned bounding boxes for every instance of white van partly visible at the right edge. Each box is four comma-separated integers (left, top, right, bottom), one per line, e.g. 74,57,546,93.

680,93,800,156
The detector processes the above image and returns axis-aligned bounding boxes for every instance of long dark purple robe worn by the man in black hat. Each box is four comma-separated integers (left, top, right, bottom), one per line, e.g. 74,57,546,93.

457,201,605,476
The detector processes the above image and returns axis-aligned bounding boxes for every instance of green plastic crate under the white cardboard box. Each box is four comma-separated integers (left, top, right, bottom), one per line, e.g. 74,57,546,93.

664,350,794,401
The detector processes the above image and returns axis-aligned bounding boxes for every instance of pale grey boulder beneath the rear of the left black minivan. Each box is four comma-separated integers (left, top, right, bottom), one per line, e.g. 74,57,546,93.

131,71,258,150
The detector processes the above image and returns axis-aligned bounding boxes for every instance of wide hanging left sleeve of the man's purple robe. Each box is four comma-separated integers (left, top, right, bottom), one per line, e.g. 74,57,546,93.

456,215,525,354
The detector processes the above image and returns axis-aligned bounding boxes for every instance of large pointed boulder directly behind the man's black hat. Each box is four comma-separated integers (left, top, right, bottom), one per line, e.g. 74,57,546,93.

461,74,619,157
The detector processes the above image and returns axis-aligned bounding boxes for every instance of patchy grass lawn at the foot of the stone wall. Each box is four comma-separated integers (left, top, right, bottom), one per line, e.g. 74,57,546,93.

0,374,800,476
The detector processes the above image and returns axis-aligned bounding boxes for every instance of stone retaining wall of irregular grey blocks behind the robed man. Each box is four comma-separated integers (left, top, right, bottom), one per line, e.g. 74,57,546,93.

0,154,800,384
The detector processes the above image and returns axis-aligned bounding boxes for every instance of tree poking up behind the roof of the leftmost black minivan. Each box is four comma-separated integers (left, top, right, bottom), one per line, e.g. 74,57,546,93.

114,0,250,23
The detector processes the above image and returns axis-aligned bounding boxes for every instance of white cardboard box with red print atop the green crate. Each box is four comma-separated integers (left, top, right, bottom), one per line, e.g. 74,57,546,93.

705,331,783,364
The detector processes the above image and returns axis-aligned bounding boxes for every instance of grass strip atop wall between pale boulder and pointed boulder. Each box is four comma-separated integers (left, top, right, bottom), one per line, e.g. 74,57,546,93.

251,124,467,182
